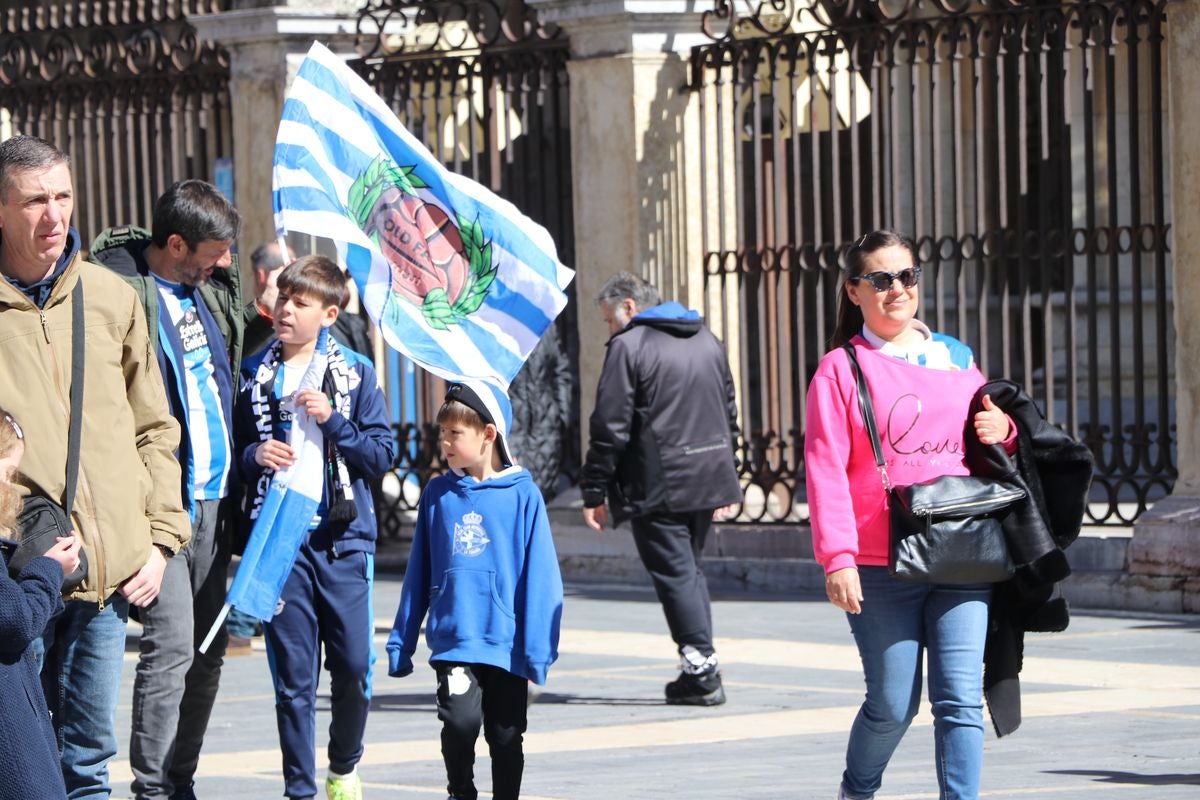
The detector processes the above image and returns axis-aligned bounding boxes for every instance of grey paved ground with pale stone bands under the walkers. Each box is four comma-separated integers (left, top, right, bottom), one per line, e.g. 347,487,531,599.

105,576,1200,800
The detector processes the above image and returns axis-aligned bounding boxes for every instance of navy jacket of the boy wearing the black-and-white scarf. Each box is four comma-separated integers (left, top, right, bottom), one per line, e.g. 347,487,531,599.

233,347,396,555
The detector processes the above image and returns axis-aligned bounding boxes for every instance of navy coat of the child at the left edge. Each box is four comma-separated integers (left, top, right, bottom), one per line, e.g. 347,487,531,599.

0,555,67,800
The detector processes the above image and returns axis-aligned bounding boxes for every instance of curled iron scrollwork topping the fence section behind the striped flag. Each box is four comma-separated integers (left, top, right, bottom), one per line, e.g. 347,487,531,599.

355,0,559,59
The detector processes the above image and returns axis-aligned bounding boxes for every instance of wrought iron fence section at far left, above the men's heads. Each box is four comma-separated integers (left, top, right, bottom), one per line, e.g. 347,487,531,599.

0,0,233,247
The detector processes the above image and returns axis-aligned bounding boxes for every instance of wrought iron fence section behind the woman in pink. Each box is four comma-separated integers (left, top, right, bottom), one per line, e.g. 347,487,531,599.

692,0,1176,524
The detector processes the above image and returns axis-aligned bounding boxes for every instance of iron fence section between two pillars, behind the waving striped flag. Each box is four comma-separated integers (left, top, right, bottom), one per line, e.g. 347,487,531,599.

350,0,580,535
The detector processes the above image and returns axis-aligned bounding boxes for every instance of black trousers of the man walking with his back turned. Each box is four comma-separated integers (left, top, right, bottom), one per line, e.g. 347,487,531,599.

631,510,713,656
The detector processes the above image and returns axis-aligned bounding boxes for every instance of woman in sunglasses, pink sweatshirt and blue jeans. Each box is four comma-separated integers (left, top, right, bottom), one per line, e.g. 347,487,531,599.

804,230,1012,800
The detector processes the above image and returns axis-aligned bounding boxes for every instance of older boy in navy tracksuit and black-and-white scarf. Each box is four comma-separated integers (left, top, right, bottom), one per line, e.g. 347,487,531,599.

234,255,396,800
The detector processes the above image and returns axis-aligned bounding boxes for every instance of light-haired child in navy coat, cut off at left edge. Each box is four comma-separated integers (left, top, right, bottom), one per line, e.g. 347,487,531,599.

0,409,79,800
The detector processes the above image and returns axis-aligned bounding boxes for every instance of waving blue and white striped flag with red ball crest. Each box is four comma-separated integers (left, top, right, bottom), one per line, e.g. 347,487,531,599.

274,43,574,389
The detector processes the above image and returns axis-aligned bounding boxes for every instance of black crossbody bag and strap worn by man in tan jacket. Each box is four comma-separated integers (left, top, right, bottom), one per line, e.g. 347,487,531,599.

7,278,88,593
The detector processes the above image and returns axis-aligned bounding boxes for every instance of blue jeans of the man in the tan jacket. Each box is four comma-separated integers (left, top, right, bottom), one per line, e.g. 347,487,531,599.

42,595,130,800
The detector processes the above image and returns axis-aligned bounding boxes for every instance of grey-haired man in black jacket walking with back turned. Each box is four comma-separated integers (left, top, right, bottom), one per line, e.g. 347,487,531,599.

580,272,742,705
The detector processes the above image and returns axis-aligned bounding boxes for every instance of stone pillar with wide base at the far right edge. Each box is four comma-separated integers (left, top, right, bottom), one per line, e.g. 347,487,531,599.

1129,0,1200,612
